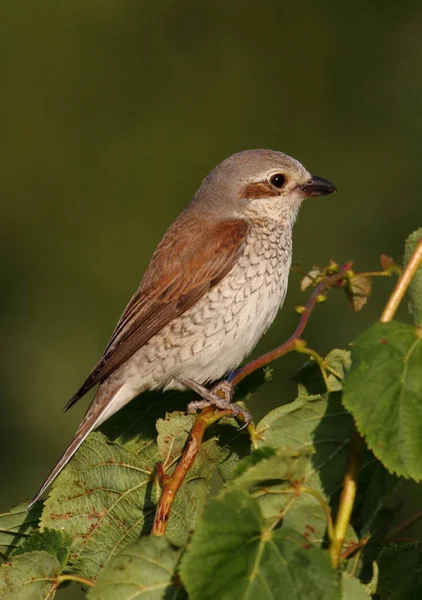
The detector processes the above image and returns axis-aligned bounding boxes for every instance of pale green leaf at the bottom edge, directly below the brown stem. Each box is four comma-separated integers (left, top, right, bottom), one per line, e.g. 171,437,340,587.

88,537,186,600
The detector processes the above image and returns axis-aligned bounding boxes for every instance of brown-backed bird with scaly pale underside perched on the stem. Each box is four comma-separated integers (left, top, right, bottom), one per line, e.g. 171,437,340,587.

28,149,337,510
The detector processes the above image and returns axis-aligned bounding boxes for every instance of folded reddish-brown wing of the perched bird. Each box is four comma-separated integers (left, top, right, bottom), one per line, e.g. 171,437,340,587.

65,217,248,410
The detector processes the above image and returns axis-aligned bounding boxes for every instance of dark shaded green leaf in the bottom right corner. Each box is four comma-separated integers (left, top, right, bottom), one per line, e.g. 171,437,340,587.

377,543,422,600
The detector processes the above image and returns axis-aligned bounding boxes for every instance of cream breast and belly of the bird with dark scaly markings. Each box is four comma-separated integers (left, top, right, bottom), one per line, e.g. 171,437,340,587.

157,228,291,382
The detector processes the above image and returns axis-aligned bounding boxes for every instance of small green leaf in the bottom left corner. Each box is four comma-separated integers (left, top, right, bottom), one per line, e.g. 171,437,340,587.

0,551,61,600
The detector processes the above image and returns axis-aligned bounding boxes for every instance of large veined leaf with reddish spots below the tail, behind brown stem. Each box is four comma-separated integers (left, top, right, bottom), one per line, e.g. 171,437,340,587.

41,432,212,579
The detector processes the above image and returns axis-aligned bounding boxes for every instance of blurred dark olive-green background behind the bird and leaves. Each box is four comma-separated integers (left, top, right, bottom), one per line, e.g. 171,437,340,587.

0,0,422,592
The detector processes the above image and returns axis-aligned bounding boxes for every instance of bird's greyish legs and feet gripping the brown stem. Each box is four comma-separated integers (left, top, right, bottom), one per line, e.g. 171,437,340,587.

179,379,252,427
